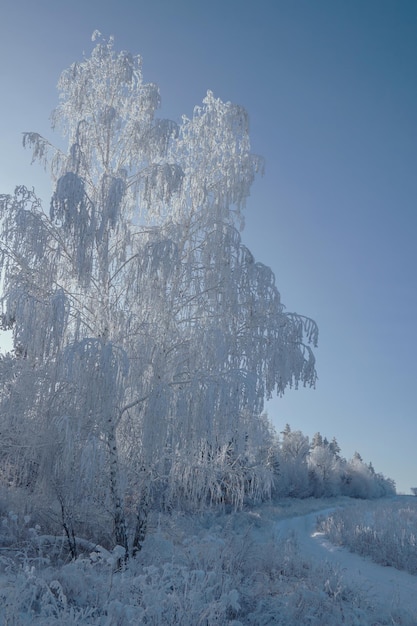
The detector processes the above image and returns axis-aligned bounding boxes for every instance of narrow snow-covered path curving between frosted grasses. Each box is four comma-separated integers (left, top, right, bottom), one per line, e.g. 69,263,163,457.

277,509,417,625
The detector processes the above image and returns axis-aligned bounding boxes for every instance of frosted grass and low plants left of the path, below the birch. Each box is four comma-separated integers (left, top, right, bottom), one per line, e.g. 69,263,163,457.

0,500,413,626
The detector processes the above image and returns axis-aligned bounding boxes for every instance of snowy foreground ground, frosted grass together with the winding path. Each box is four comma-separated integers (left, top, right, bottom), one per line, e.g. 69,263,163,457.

0,498,417,626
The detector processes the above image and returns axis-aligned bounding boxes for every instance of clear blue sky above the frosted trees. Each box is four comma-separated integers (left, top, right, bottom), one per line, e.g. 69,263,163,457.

0,0,417,492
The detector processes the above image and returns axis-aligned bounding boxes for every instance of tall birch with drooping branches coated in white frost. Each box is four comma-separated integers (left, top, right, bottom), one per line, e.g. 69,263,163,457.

0,37,317,552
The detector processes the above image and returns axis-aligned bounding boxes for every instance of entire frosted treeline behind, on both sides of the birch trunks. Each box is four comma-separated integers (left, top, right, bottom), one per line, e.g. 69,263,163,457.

0,380,395,557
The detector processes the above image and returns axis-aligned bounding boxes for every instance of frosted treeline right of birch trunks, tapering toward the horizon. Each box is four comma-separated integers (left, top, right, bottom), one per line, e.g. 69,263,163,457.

127,415,396,510
